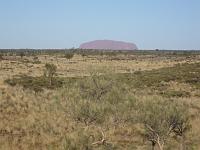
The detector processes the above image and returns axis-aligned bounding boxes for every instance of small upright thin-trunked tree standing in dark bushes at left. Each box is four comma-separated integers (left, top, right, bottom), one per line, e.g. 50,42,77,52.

44,63,57,86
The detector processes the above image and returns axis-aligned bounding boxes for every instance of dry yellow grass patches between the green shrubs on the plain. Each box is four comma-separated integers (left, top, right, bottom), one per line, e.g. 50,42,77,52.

0,52,200,150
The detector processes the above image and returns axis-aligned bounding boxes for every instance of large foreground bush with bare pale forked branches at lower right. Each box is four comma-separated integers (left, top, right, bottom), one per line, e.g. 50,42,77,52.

139,99,188,150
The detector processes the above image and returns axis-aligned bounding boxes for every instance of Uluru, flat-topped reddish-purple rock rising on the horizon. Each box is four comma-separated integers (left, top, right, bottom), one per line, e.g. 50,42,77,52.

79,40,138,50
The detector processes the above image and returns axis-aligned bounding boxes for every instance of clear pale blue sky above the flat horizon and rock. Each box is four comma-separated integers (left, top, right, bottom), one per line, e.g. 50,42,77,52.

0,0,200,49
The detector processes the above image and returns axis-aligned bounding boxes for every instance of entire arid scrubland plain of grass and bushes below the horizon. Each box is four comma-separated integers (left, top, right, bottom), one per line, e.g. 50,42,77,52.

0,51,200,150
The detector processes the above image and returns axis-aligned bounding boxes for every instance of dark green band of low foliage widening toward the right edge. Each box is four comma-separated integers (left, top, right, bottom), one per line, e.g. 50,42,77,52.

115,63,200,89
